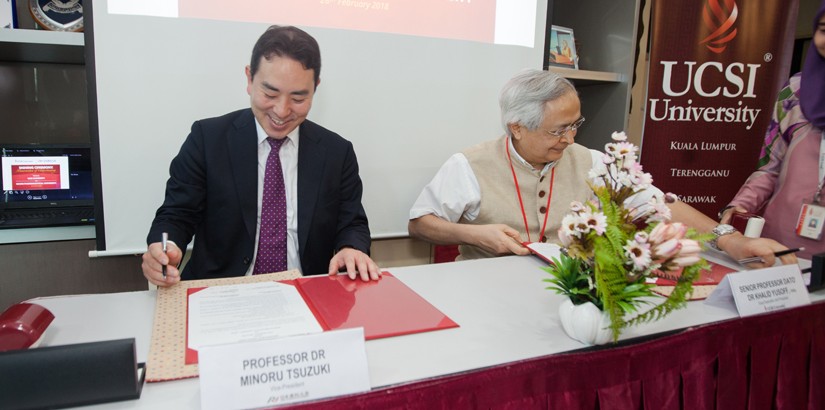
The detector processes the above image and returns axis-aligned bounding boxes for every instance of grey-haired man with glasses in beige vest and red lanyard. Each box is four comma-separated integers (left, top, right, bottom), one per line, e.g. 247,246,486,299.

408,70,796,268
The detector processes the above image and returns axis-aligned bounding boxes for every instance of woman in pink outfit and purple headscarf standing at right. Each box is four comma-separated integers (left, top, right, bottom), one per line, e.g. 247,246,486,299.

719,0,825,259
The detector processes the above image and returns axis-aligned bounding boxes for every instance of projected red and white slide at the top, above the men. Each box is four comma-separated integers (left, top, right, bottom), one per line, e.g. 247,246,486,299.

108,0,537,47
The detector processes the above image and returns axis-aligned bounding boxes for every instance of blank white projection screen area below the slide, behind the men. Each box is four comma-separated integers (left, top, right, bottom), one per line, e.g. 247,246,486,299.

86,0,547,255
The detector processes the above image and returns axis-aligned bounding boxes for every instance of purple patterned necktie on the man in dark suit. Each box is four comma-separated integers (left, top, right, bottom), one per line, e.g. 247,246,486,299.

252,138,286,275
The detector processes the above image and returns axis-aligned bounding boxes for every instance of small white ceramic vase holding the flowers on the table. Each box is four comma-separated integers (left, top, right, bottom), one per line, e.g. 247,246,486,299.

559,298,612,345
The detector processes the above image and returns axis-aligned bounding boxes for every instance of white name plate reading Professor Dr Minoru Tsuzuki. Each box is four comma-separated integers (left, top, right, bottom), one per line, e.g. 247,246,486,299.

199,328,370,409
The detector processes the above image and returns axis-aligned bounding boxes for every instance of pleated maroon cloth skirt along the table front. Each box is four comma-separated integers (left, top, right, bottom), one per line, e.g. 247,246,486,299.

295,303,825,410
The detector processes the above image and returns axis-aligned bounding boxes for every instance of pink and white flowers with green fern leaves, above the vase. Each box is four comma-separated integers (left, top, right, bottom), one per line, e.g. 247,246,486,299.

544,132,709,341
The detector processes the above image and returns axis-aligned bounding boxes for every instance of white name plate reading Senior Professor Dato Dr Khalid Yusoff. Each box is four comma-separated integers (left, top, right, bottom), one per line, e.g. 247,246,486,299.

705,265,811,317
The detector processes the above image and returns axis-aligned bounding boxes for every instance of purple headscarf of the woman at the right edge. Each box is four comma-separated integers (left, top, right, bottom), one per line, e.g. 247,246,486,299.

800,0,825,130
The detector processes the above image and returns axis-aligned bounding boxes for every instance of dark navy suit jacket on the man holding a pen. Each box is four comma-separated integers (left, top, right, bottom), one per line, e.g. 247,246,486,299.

146,109,370,279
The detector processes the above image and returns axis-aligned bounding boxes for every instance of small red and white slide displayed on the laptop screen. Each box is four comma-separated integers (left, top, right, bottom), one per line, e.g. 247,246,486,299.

3,157,69,191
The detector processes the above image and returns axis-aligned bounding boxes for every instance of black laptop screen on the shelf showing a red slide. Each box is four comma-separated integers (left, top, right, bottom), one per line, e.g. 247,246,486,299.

0,145,94,210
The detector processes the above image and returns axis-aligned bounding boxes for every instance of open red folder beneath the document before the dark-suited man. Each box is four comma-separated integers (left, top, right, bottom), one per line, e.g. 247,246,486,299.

186,271,458,364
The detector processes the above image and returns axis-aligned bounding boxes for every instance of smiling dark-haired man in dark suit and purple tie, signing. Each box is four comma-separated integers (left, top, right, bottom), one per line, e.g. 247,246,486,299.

142,26,380,286
